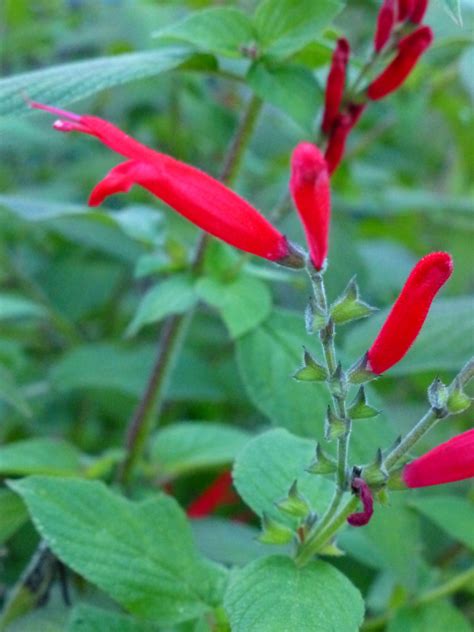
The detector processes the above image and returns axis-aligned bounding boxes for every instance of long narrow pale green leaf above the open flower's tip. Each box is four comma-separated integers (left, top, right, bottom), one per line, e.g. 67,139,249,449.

0,48,190,116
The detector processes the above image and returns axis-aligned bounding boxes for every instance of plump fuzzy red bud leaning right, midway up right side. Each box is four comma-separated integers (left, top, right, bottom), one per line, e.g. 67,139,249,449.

367,252,453,374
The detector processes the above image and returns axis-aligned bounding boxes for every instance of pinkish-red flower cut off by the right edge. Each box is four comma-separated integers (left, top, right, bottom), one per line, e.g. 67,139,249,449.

402,428,474,487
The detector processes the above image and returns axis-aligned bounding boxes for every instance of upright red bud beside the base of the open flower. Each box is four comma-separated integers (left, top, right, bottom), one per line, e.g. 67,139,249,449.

290,142,331,270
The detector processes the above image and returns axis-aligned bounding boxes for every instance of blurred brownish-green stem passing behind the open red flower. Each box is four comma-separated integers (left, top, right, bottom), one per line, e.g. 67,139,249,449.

118,95,262,485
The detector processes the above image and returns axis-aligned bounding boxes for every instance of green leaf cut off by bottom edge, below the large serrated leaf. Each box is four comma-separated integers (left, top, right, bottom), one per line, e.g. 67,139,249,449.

66,604,158,632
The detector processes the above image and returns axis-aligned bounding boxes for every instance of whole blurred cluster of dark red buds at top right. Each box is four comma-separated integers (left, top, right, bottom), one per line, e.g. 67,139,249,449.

321,0,433,173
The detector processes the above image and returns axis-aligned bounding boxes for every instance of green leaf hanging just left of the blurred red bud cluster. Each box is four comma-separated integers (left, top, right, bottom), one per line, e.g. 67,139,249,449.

247,61,320,131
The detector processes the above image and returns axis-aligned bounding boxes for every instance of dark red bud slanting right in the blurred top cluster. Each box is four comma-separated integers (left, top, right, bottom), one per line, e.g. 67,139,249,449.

367,26,433,101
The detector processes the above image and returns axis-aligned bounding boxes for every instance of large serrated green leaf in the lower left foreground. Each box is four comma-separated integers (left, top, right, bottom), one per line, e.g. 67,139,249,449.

10,476,228,624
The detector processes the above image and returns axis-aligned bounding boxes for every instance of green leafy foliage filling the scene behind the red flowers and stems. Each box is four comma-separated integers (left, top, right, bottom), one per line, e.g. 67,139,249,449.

0,0,474,632
